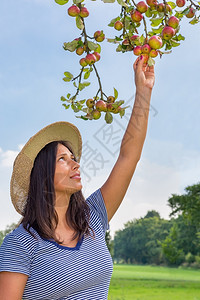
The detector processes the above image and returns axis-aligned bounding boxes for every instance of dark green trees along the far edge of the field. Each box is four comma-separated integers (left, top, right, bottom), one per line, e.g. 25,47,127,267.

0,183,200,268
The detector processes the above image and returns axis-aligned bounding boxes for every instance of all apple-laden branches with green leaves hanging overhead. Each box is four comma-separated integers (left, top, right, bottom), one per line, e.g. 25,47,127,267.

55,0,200,123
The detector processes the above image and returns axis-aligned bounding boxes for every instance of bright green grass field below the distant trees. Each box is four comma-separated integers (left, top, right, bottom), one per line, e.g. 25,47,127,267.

108,265,200,300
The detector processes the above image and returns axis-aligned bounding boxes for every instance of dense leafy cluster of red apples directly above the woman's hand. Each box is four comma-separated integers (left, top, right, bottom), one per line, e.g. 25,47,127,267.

108,0,200,65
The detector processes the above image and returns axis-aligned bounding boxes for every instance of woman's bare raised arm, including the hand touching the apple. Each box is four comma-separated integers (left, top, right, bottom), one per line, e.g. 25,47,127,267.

101,58,155,221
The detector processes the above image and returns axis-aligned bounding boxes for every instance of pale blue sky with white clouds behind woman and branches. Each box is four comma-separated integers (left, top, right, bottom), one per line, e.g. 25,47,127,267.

0,0,200,236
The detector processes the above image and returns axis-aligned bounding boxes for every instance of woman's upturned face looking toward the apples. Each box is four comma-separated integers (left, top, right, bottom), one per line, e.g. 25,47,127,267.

54,144,82,198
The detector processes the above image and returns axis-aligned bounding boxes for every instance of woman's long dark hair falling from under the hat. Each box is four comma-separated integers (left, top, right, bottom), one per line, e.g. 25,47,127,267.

21,141,94,244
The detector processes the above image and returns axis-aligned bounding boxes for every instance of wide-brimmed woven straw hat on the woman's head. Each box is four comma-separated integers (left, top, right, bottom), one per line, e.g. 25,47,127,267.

10,122,82,215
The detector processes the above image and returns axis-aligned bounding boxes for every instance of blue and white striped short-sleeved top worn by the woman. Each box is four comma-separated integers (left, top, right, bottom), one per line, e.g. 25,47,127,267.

0,189,113,300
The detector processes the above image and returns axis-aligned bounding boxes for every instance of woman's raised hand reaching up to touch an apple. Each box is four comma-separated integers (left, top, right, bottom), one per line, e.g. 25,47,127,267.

133,56,155,90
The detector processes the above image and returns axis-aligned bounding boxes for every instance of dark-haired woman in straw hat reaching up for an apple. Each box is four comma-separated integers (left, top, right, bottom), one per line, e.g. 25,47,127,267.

0,58,154,300
